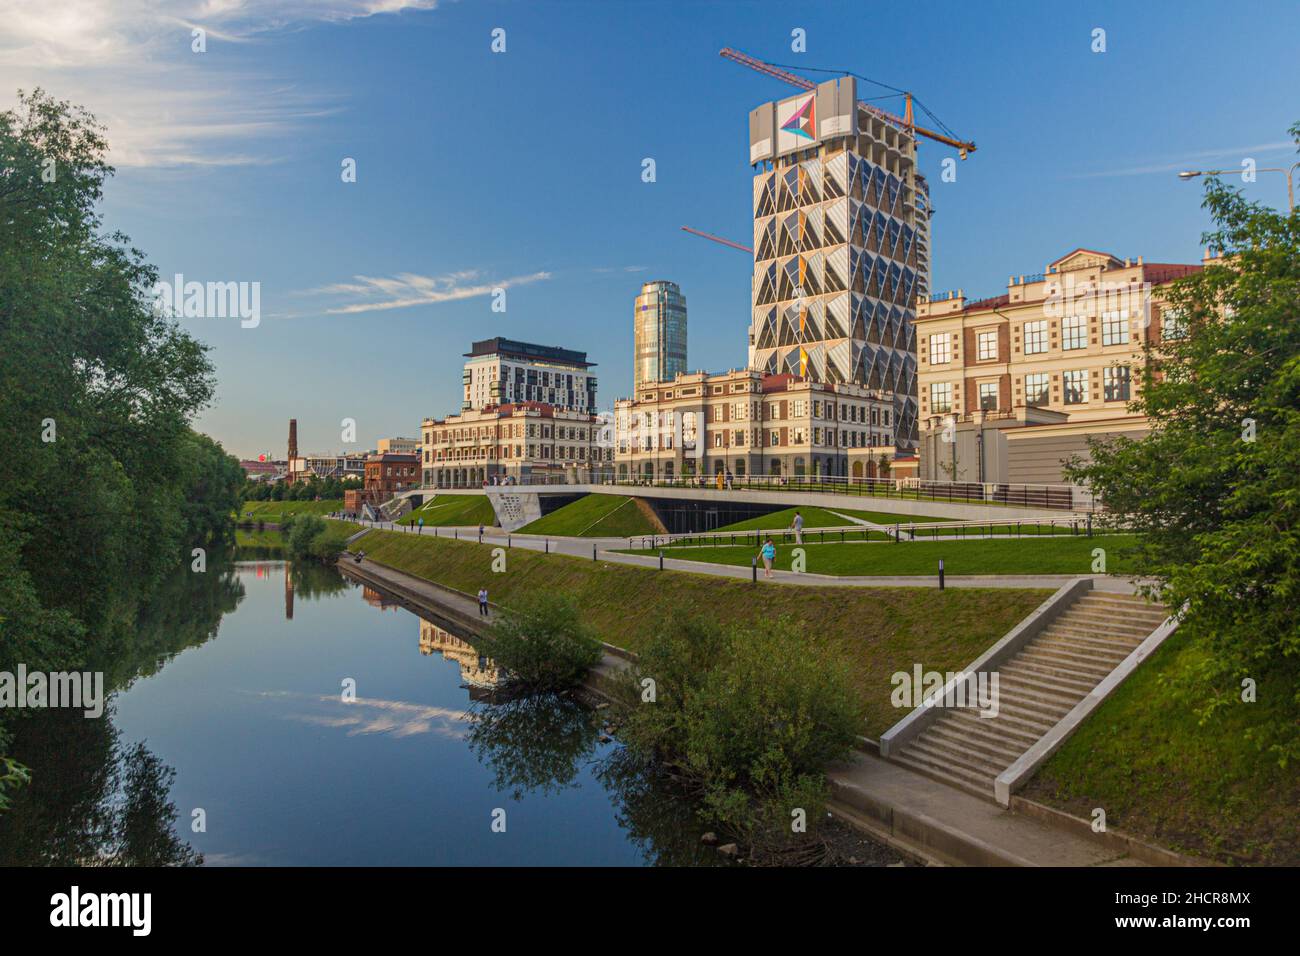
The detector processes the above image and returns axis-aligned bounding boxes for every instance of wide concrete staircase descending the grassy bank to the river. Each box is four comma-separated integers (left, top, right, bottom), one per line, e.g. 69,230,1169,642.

891,591,1167,797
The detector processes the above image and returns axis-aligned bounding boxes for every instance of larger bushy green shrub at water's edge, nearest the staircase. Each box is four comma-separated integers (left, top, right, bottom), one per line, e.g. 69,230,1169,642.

620,618,863,855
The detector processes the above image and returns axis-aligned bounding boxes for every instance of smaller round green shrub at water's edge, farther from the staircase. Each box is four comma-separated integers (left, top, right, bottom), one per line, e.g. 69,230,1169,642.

475,593,602,692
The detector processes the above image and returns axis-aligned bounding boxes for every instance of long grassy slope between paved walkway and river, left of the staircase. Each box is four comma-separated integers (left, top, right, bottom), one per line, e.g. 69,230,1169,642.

354,531,1050,736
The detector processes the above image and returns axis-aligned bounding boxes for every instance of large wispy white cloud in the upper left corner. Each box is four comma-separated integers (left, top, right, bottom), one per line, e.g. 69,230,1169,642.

0,0,438,166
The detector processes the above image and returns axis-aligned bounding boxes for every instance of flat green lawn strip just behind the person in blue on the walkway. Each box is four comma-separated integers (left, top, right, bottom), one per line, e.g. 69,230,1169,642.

618,535,1134,575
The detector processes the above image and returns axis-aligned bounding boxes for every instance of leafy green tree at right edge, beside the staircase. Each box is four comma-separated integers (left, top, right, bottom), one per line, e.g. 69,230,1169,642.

1069,124,1300,762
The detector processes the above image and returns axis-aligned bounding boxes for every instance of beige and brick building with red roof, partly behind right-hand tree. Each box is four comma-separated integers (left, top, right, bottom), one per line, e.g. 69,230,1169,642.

917,248,1203,484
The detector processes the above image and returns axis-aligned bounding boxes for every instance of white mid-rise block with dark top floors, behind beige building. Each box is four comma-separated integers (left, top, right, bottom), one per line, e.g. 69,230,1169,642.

462,337,595,412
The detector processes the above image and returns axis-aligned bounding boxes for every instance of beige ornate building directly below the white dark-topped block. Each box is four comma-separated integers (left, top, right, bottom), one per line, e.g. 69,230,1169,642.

420,402,610,488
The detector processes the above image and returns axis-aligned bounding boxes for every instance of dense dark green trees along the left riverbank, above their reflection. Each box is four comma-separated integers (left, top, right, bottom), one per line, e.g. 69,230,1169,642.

0,91,243,806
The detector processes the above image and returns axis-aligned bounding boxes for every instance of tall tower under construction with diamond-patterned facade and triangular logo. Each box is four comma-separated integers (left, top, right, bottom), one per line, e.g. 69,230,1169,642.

749,77,931,447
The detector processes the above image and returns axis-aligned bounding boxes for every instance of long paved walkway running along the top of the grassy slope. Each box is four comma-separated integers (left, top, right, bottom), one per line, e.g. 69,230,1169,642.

359,522,1136,593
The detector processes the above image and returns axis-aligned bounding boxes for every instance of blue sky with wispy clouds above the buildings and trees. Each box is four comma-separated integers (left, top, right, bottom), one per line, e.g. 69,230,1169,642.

0,0,1300,457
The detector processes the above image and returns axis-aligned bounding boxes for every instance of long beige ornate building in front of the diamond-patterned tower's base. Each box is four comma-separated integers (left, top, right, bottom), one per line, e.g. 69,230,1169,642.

614,369,897,480
